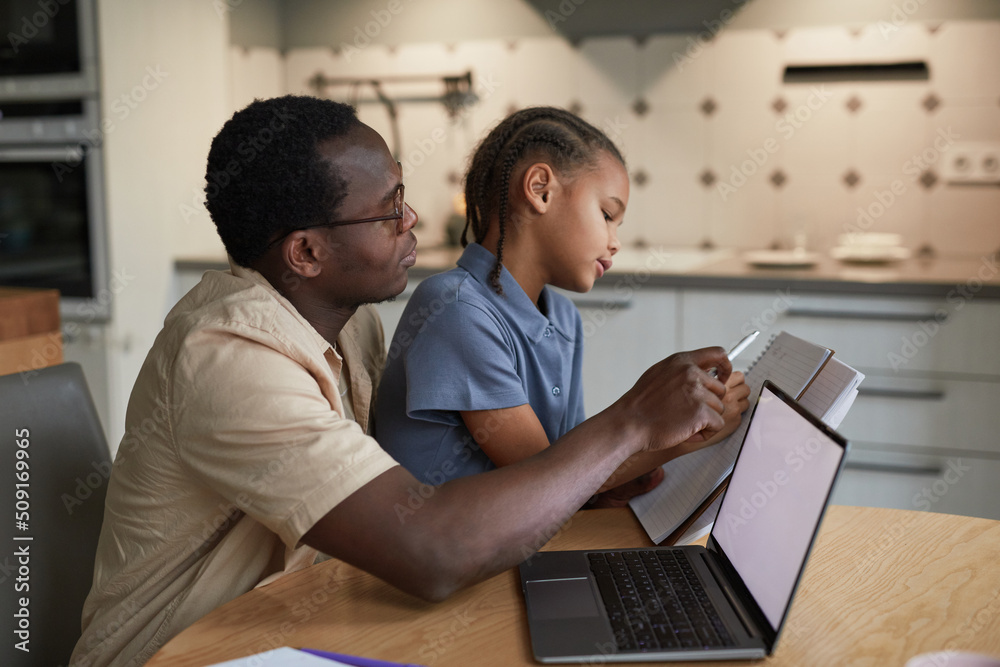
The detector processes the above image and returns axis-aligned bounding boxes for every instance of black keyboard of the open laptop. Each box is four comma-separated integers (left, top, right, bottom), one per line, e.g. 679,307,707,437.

587,550,733,652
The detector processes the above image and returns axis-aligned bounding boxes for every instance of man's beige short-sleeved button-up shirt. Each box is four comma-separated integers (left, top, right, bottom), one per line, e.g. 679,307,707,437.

71,265,396,665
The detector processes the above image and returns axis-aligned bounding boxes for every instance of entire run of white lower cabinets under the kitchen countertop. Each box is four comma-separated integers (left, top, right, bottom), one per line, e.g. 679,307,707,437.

378,281,1000,519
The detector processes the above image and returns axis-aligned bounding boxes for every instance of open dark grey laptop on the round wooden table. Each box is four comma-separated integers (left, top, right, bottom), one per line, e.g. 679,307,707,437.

520,381,848,662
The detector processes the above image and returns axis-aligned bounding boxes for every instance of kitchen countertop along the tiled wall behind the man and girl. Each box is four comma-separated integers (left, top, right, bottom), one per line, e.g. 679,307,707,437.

175,247,1000,299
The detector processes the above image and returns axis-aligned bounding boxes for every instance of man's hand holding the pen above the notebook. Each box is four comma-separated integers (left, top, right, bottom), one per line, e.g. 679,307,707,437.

610,347,732,451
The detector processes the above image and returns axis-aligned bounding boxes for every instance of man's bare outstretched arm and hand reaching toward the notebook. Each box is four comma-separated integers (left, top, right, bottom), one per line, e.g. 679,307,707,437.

302,348,731,600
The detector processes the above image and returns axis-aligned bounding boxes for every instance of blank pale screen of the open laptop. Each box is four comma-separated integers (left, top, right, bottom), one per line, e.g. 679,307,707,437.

712,387,844,628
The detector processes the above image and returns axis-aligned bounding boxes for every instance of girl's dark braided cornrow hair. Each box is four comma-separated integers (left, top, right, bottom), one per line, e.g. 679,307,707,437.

462,107,625,295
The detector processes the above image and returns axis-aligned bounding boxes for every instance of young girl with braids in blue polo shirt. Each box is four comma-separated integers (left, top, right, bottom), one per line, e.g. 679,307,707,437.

375,107,747,504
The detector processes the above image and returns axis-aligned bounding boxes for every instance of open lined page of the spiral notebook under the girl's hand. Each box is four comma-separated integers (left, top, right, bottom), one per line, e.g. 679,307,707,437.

629,331,833,543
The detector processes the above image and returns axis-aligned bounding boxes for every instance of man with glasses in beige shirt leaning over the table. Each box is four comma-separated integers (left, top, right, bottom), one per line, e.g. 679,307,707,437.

73,96,730,665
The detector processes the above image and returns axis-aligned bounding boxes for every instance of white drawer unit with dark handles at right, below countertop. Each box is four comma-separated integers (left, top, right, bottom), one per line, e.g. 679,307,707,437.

678,289,1000,519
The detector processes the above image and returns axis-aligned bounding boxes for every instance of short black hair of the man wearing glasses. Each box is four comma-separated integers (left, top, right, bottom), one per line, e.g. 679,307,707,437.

205,95,361,266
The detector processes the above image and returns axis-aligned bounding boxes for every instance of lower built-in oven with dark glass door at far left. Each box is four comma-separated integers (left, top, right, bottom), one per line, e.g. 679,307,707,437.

0,99,111,321
